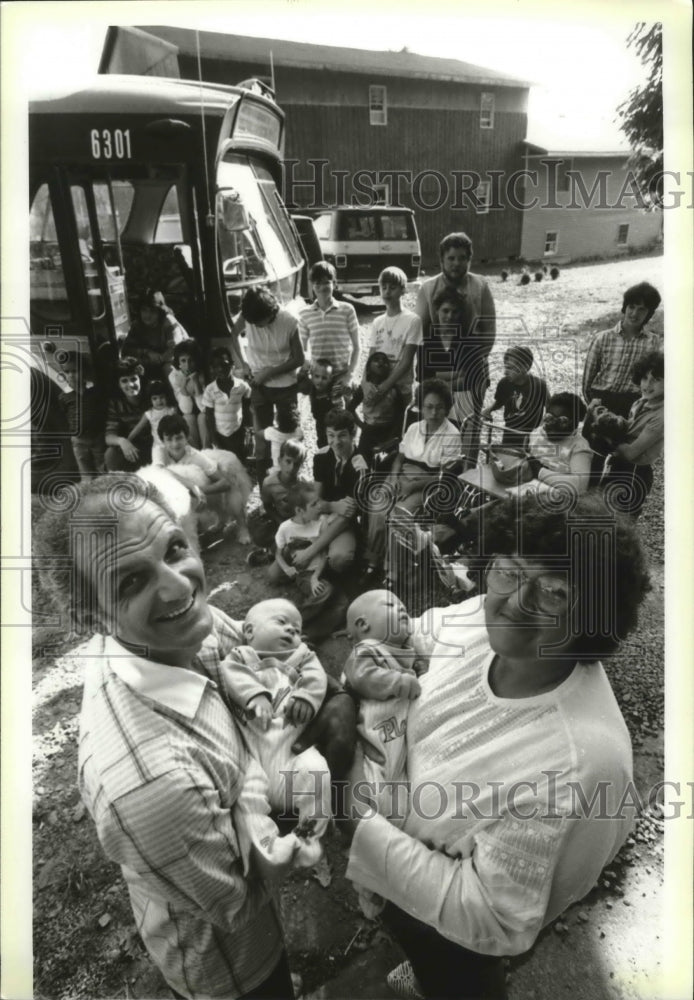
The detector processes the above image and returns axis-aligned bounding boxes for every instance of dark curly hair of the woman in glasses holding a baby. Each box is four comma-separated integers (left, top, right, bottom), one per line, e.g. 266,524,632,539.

481,493,651,662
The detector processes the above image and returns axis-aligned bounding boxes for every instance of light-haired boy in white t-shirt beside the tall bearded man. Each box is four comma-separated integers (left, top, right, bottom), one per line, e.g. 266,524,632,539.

369,267,422,412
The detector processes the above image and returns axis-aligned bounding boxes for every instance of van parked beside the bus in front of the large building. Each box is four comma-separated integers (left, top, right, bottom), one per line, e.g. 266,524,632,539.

312,205,421,295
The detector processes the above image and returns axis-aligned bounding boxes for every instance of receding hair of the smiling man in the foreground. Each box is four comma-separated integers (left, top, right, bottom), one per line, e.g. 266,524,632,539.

33,472,178,635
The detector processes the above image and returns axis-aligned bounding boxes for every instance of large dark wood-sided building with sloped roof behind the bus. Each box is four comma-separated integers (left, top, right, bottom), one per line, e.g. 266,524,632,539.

100,26,530,272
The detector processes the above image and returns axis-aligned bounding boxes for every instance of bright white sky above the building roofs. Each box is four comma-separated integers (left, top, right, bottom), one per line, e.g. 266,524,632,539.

3,0,678,148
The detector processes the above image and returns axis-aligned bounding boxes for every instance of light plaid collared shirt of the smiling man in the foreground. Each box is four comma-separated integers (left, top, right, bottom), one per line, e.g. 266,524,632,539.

79,608,283,997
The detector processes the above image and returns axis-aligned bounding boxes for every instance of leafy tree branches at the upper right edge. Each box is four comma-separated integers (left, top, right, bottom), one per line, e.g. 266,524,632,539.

617,21,663,208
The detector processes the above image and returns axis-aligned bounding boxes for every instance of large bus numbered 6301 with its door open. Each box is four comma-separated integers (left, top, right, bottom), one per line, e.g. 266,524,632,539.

29,75,303,478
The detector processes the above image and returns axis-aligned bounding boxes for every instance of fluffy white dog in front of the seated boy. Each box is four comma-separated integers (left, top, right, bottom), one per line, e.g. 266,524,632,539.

137,448,252,545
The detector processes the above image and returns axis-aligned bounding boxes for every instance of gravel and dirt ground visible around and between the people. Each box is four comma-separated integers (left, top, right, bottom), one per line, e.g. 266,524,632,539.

31,256,663,1000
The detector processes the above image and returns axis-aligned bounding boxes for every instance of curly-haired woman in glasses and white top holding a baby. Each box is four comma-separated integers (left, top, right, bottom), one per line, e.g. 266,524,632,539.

347,495,649,1000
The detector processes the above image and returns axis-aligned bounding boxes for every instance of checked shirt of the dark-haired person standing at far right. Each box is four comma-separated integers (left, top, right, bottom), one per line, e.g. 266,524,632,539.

583,320,663,401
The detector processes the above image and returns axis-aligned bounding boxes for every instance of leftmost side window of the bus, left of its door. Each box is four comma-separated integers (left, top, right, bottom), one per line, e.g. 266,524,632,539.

29,184,72,324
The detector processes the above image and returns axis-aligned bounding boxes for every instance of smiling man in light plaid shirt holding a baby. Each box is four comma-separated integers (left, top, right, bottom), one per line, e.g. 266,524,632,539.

34,475,355,998
